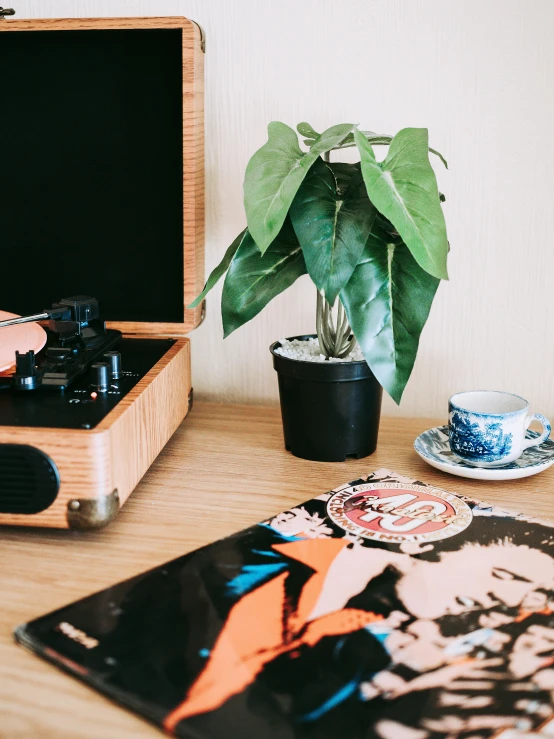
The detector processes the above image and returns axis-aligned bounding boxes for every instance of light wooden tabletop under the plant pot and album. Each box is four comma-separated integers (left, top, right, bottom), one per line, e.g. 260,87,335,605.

0,404,554,739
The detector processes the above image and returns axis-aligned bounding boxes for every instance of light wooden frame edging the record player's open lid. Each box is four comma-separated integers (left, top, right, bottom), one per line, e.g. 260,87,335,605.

0,17,204,337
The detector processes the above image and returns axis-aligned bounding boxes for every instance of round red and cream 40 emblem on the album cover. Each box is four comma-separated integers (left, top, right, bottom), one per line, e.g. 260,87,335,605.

327,483,472,544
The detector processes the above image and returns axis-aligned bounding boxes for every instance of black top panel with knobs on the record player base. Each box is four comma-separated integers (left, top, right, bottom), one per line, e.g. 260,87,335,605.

0,338,175,429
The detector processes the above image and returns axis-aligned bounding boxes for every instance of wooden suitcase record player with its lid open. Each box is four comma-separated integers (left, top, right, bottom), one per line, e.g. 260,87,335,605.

0,18,204,529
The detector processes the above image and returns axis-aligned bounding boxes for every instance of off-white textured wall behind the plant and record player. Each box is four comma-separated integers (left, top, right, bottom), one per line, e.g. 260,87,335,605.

11,0,554,416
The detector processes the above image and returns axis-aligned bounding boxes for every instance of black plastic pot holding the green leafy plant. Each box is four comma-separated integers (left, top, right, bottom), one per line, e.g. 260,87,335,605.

270,336,383,462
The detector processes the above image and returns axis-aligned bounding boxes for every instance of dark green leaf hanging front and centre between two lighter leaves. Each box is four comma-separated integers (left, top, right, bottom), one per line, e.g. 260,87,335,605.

290,159,377,305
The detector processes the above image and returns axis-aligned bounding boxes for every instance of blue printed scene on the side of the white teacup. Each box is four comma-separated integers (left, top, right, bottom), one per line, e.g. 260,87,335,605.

450,411,512,462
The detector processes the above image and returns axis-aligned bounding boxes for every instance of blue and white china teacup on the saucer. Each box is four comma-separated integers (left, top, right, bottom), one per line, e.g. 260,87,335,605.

448,390,551,467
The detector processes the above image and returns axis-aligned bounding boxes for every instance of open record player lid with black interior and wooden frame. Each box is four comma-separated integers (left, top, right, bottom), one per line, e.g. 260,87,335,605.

0,18,204,336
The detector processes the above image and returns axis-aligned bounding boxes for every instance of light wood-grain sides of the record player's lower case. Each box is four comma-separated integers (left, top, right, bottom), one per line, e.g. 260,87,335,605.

0,339,191,528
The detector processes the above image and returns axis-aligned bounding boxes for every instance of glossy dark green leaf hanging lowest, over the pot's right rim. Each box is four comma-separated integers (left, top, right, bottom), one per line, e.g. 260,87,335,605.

340,218,440,403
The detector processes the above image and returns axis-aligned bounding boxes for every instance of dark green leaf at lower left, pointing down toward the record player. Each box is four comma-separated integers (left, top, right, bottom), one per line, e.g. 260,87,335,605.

221,219,306,337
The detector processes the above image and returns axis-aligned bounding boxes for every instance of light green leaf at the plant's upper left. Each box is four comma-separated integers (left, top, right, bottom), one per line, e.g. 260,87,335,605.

244,121,354,254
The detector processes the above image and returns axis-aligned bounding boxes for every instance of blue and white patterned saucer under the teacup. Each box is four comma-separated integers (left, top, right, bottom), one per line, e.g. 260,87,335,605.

414,426,554,480
